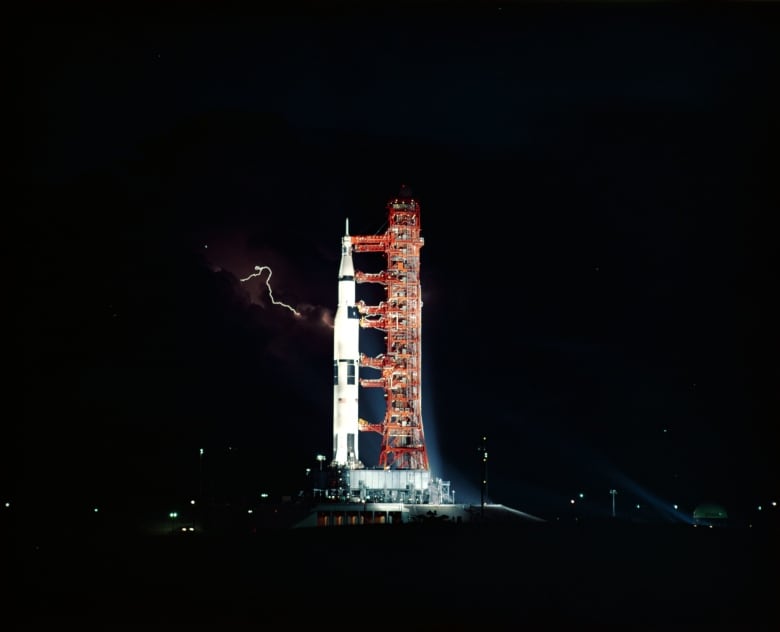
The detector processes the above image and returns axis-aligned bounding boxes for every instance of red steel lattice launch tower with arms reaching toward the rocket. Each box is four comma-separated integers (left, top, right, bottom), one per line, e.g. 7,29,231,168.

351,186,429,470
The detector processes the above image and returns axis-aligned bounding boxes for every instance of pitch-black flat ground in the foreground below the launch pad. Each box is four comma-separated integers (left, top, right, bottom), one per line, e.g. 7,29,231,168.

13,523,780,630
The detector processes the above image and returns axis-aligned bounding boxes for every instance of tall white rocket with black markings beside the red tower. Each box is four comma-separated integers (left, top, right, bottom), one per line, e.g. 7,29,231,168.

333,220,360,468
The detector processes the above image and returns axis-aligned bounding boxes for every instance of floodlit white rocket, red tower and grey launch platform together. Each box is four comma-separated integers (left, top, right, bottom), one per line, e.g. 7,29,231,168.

322,186,453,524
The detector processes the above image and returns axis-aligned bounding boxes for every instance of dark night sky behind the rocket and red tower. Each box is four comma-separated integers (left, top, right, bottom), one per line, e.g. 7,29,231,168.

13,2,780,519
